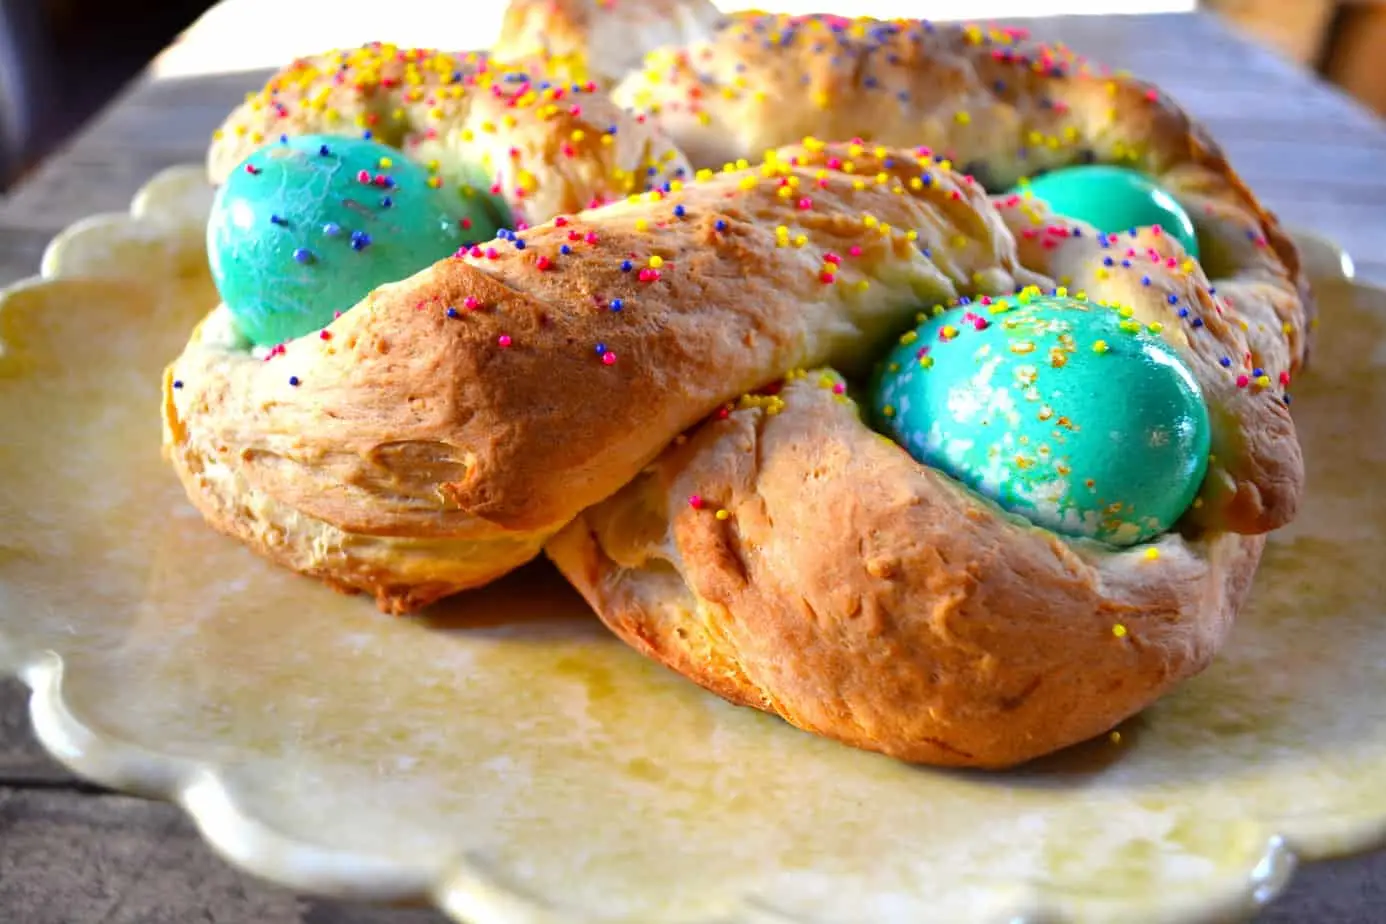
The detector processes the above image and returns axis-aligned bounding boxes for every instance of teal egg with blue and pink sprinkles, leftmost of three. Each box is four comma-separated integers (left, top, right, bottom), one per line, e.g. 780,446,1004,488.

207,136,510,346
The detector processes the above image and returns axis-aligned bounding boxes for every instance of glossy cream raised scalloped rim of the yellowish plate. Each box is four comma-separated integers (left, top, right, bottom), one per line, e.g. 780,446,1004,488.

0,163,1386,924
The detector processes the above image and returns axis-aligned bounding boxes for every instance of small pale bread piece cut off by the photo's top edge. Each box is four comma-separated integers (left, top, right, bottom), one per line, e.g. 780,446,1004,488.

491,0,721,86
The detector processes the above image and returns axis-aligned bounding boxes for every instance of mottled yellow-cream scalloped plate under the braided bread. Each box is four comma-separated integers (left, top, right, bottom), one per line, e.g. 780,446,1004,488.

0,168,1386,924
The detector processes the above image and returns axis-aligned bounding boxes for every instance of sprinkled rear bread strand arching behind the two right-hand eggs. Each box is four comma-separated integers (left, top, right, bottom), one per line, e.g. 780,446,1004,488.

614,14,1313,532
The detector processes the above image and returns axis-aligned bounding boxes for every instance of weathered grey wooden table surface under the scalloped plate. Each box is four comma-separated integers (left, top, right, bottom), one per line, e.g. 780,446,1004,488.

0,7,1386,924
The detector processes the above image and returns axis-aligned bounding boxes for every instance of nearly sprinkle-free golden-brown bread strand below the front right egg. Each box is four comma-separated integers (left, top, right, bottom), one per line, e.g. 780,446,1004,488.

547,373,1264,767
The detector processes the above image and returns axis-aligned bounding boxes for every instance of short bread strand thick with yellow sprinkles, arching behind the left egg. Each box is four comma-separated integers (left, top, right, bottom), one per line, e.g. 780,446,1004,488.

208,43,687,224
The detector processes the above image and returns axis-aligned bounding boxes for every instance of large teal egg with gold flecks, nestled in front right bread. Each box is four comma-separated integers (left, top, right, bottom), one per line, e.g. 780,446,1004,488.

870,295,1209,546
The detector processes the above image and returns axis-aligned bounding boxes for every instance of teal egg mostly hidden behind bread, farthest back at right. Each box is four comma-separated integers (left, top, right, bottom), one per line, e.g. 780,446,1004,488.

1012,165,1199,259
